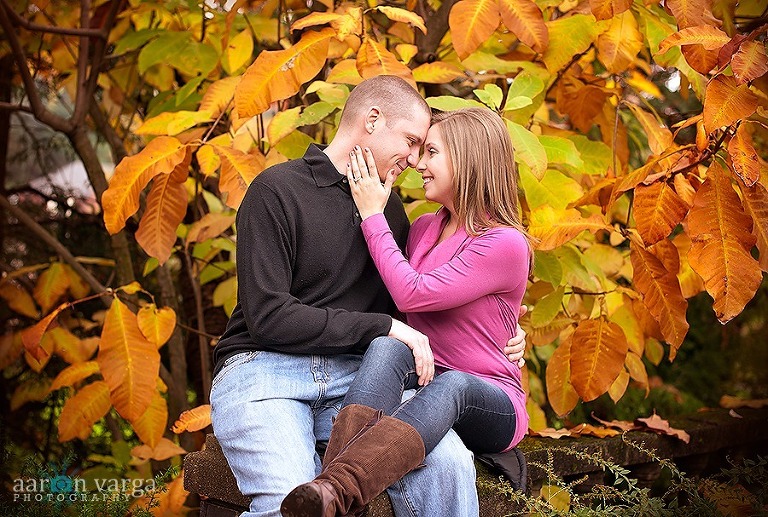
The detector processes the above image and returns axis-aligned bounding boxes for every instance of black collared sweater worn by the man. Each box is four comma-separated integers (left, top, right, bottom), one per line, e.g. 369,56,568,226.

214,145,408,375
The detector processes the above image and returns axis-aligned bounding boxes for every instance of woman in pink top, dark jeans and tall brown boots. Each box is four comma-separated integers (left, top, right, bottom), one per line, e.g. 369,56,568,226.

281,108,532,516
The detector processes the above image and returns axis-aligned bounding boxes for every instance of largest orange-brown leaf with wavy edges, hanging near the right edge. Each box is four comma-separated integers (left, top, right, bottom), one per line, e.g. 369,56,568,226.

688,161,763,323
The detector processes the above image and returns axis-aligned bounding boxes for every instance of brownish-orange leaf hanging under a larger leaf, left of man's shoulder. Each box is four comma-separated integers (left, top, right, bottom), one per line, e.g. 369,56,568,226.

136,172,191,265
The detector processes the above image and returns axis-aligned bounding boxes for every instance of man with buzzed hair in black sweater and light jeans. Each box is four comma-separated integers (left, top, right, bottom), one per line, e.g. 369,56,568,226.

211,76,524,517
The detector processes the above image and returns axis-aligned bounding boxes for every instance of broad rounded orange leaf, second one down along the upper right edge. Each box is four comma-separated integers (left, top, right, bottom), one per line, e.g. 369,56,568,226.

704,75,757,133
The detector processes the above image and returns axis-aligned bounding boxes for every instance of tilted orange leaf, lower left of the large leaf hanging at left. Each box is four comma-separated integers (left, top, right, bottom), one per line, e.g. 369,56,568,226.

59,381,110,442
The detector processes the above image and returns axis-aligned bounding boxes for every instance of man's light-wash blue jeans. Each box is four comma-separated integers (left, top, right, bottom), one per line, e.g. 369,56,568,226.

211,346,479,517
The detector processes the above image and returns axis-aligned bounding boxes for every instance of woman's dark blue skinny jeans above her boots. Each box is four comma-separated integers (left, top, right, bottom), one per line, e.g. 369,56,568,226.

344,337,515,452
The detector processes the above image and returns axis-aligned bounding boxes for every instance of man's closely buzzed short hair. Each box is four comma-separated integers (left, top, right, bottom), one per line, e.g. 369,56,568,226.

339,75,431,127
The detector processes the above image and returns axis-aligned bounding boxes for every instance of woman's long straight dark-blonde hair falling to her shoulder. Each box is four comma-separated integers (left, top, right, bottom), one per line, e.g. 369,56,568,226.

432,108,531,253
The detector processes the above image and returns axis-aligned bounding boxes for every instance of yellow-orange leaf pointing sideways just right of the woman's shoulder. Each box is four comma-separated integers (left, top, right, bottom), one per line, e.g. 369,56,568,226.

528,205,610,250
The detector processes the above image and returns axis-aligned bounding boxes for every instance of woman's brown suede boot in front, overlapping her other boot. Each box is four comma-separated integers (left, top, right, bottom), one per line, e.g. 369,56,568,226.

280,416,424,517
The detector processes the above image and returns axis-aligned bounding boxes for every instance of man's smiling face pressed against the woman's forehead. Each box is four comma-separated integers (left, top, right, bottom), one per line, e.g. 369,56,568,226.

368,110,430,181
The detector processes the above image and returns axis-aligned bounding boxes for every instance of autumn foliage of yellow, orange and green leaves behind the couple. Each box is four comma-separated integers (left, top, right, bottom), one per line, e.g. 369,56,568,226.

0,0,768,514
